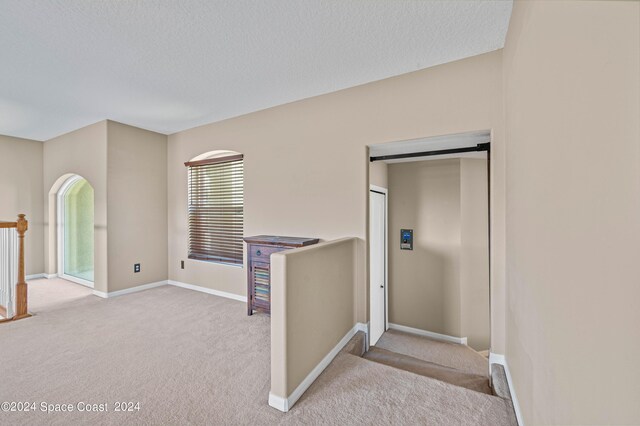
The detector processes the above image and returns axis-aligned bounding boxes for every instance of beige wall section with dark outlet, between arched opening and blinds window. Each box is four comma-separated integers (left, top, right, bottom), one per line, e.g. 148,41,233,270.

107,121,167,292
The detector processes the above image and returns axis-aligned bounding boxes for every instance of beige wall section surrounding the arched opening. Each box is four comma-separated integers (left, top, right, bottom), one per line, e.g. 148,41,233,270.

43,121,108,292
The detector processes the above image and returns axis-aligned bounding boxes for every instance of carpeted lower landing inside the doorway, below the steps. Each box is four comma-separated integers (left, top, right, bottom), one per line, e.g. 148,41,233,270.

376,330,489,378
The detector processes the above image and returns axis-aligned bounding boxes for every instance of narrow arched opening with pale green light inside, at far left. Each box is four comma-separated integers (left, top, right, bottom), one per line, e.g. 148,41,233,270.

56,175,94,288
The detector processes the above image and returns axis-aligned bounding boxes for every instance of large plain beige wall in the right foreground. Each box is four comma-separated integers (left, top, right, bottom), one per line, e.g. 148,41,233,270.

504,1,640,424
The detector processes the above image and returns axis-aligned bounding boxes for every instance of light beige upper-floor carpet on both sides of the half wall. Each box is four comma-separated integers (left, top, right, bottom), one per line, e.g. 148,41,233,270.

0,286,511,425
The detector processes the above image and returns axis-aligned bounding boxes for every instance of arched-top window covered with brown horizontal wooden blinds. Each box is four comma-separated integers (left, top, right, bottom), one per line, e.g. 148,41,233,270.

185,155,244,265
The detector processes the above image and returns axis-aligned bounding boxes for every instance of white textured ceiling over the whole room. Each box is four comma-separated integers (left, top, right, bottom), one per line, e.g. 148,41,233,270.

0,0,512,140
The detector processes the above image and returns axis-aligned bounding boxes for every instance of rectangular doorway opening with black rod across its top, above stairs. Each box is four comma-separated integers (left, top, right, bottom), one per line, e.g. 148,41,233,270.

365,131,491,382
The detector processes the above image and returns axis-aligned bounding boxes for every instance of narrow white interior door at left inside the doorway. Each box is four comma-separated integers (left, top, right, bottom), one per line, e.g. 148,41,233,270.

369,190,387,345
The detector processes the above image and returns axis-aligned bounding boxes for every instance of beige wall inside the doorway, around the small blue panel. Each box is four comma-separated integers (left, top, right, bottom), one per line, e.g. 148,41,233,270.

389,159,490,350
